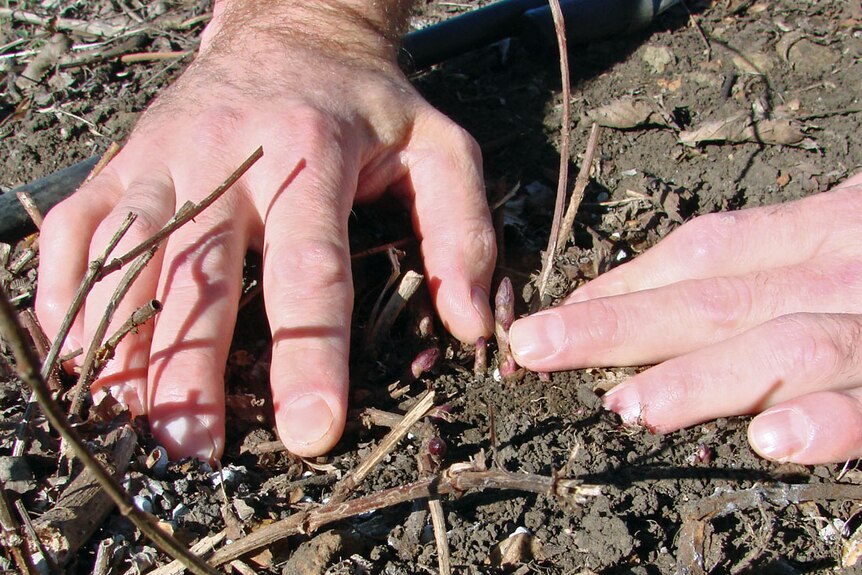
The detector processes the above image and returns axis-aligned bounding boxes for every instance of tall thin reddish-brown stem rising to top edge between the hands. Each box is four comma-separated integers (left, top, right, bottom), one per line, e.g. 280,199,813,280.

533,0,571,308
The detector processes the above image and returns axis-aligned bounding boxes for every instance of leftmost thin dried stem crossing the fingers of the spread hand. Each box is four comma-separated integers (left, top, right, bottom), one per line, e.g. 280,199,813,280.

12,214,137,457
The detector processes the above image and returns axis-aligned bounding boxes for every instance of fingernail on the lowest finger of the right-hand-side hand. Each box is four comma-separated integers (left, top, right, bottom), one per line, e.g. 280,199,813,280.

748,409,811,461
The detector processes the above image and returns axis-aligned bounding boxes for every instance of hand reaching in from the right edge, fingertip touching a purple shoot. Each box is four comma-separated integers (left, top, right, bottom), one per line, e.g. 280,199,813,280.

510,174,862,464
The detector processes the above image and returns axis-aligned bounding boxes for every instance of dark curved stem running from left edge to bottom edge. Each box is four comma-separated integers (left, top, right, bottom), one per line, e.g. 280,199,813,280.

0,293,218,575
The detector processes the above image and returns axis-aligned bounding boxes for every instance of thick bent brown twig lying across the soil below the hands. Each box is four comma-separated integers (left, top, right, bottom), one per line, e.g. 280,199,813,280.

210,463,600,566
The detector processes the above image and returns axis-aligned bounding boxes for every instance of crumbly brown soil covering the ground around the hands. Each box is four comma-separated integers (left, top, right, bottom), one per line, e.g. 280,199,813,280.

0,0,862,574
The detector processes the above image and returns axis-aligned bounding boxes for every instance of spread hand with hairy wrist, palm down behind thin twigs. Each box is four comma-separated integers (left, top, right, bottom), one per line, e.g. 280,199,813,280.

36,0,495,459
